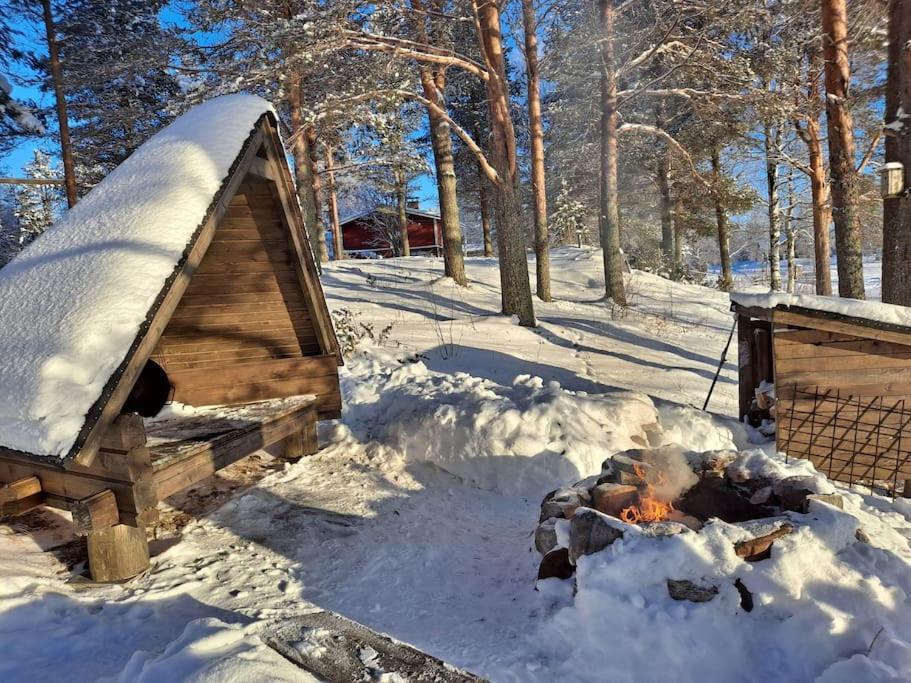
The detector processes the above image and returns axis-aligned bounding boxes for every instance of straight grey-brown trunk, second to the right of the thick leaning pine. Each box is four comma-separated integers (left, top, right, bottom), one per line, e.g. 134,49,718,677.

598,0,626,306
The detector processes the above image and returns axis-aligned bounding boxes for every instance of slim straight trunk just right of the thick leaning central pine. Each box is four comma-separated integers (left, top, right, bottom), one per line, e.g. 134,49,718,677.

522,0,552,301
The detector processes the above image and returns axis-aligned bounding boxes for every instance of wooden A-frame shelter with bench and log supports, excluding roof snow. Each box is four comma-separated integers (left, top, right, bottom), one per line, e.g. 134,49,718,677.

0,96,342,581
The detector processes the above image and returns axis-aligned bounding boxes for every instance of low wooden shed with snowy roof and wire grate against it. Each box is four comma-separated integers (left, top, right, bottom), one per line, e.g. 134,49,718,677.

731,293,911,495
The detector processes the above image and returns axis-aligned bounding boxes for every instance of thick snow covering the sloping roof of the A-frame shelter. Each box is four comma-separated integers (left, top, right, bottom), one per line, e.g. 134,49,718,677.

0,94,273,458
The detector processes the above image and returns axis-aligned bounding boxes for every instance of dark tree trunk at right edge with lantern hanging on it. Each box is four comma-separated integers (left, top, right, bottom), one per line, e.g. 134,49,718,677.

882,0,911,306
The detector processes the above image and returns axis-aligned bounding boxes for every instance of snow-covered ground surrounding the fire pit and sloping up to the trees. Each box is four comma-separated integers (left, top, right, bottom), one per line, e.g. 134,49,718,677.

0,249,911,681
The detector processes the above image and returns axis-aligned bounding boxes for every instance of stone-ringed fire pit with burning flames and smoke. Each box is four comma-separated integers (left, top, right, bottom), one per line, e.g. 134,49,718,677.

535,446,842,602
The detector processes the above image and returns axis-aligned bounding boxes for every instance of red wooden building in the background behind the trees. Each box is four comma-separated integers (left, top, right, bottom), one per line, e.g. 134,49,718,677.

341,206,443,258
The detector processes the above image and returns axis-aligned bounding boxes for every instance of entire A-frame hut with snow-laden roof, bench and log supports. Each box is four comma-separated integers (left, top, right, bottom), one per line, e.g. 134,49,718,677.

0,95,341,580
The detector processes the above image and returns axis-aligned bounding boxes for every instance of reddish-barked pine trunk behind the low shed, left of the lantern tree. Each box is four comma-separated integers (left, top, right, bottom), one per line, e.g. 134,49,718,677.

822,0,864,299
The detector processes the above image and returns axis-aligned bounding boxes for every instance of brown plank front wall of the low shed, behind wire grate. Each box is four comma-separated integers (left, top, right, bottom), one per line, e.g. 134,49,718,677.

774,326,911,487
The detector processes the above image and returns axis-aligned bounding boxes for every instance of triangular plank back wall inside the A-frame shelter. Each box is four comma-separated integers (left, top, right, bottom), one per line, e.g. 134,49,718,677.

152,176,341,417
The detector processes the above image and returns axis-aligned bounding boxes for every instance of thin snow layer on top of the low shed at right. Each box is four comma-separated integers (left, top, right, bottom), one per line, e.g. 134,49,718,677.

731,292,911,328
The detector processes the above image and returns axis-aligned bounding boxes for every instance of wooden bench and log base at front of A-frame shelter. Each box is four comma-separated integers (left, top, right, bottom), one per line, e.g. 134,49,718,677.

0,396,318,581
